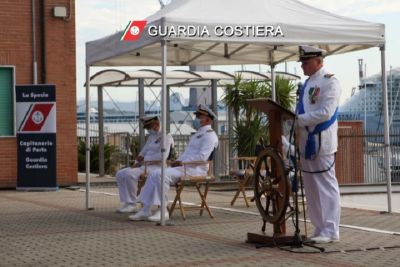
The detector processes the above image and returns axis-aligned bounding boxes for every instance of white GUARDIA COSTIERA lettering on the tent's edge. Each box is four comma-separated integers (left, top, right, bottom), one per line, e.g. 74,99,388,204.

148,25,284,37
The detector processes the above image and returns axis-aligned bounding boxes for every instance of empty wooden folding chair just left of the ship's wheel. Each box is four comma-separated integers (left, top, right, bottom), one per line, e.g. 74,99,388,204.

230,157,257,207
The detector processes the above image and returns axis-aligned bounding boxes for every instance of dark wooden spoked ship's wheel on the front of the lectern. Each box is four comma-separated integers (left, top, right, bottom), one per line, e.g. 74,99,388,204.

254,147,290,224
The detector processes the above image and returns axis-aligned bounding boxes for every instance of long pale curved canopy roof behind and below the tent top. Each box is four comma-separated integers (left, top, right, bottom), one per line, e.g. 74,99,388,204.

90,69,300,86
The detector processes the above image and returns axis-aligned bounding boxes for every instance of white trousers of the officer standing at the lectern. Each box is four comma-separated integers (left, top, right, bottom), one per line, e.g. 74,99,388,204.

300,154,340,238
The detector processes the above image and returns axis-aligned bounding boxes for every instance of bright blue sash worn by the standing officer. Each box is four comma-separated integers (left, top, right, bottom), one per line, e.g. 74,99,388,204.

297,79,339,159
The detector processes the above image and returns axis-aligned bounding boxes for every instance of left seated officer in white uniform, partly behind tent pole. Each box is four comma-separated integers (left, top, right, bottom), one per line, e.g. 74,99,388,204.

115,116,174,213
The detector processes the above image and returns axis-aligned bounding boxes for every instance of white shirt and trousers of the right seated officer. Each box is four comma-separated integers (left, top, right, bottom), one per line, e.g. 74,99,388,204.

139,125,218,212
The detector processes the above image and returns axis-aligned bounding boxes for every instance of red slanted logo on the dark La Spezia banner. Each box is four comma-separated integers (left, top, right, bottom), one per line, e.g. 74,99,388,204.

22,103,54,132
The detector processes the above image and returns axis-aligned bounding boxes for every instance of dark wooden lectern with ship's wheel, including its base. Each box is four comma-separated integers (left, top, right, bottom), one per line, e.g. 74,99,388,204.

247,98,299,246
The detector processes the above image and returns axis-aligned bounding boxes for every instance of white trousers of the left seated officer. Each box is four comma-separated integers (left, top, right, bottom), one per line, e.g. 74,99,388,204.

115,165,160,204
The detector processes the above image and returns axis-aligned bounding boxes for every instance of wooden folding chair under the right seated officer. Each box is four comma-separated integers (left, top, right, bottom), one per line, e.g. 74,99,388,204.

169,152,215,220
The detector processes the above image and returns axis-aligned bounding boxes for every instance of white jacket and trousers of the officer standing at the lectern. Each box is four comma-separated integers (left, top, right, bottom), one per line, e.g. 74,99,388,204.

297,67,341,239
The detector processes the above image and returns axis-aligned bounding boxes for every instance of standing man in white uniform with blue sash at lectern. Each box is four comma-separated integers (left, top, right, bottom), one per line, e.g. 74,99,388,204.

296,46,341,243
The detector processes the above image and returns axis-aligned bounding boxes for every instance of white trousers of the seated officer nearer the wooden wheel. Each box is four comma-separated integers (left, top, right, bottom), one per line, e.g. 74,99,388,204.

139,167,183,212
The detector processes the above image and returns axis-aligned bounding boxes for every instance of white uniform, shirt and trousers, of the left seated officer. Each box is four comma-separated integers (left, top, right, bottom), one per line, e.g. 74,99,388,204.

116,131,174,206
